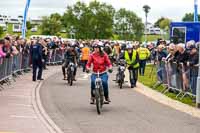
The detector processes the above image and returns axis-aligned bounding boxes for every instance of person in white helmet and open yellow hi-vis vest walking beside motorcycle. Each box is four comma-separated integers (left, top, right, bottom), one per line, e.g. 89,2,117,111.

120,44,139,88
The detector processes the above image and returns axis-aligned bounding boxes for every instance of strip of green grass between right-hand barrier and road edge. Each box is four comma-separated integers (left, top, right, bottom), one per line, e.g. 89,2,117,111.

139,65,195,106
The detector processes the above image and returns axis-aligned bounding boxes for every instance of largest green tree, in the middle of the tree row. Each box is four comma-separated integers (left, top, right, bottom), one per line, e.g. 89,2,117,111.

62,1,115,39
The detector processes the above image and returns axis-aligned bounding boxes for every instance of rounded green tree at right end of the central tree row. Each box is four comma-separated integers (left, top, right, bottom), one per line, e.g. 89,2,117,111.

114,8,144,40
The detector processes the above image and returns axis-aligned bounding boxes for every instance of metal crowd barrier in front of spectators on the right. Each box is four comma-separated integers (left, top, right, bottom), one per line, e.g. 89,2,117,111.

154,61,198,99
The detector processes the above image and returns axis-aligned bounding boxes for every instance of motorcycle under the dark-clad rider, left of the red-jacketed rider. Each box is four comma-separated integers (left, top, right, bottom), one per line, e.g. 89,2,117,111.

67,62,75,86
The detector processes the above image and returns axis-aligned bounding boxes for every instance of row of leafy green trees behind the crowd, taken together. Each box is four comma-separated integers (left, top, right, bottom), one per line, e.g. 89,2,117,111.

41,1,144,40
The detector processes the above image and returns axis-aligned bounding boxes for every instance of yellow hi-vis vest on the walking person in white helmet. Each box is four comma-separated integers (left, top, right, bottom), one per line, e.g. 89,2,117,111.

125,50,139,68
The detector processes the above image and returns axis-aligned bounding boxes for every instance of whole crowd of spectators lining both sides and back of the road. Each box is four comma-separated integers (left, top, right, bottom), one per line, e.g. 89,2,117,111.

0,35,200,98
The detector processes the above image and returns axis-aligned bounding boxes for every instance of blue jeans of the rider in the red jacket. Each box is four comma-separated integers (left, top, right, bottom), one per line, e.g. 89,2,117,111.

91,73,109,98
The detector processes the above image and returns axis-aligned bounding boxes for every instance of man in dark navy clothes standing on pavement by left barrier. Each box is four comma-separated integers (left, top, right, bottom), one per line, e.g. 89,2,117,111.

30,40,44,81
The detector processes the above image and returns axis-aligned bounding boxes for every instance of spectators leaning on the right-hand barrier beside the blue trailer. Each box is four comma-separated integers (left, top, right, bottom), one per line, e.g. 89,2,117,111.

147,40,200,95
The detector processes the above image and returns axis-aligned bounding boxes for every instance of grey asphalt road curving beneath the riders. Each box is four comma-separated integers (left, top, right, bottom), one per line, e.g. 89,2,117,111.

40,68,200,133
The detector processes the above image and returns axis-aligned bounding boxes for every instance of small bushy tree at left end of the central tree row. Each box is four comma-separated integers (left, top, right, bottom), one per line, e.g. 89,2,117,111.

41,13,62,35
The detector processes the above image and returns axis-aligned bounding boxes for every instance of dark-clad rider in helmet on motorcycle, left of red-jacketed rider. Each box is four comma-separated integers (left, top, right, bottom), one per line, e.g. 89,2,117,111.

62,43,78,80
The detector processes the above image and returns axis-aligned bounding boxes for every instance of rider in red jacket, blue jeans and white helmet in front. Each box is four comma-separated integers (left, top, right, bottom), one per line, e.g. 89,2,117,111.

86,43,112,104
